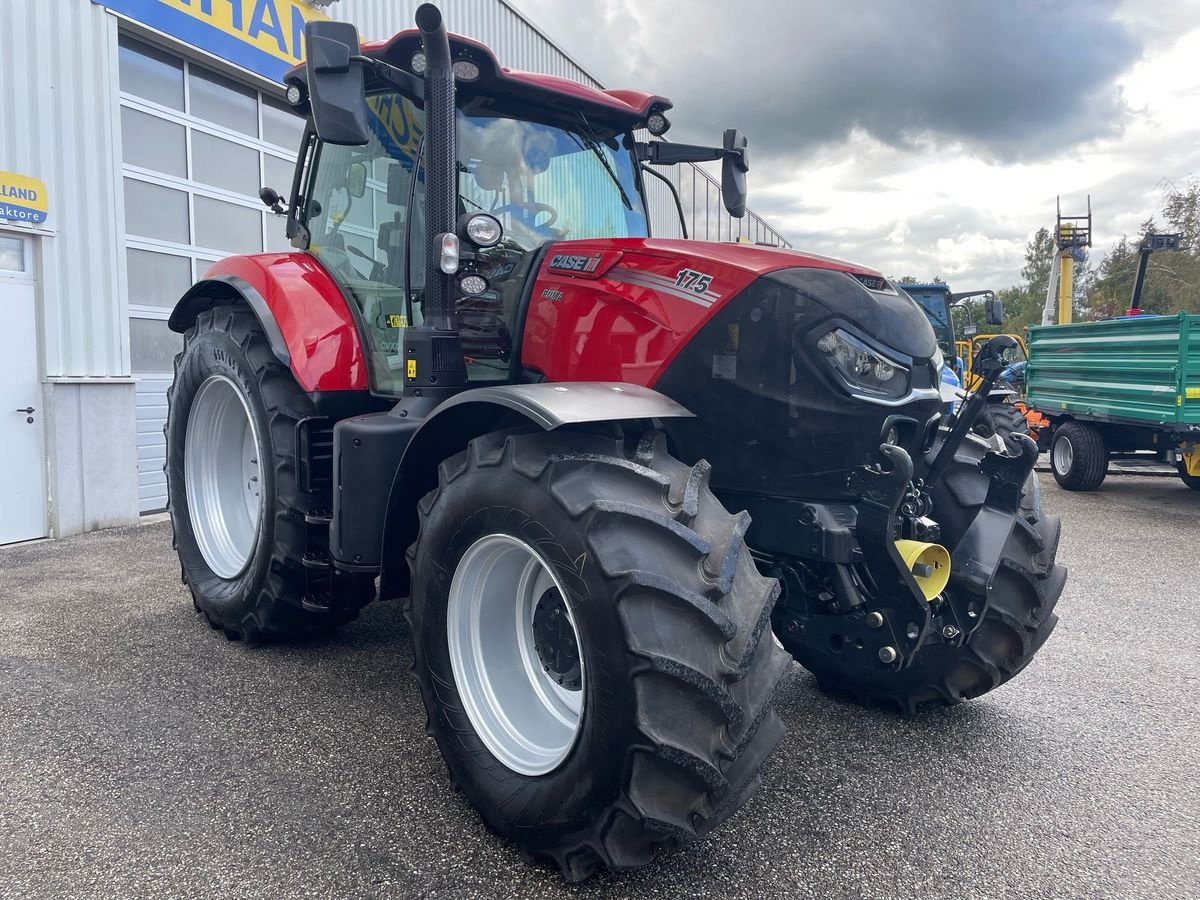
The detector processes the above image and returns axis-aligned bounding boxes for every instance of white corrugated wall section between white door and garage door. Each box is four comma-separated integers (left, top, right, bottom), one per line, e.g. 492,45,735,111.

0,0,137,535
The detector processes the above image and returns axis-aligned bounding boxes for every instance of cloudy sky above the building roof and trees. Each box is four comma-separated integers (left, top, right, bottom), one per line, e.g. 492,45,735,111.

514,0,1200,289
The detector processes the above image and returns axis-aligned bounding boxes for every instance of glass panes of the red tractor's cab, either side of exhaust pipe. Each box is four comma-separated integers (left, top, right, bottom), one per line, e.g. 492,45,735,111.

304,94,648,394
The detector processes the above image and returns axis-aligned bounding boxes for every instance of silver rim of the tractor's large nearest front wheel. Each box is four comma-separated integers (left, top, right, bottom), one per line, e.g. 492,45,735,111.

446,534,587,775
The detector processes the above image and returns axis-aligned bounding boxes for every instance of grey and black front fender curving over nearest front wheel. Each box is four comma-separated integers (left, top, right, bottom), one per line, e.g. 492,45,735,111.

374,382,692,599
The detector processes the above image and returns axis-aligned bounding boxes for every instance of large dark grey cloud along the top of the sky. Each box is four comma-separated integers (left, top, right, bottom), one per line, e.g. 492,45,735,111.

511,0,1140,161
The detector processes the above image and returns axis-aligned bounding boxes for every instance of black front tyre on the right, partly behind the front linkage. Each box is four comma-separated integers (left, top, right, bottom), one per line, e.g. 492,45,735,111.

784,439,1067,715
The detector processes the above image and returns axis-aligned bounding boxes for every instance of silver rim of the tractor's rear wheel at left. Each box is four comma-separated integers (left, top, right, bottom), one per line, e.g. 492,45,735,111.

184,374,263,580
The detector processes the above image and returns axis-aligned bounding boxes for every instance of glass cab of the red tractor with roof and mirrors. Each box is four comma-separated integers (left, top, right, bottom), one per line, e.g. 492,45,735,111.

287,23,748,395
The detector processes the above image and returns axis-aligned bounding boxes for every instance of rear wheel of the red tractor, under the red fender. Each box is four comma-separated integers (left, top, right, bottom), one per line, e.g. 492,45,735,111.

163,306,374,642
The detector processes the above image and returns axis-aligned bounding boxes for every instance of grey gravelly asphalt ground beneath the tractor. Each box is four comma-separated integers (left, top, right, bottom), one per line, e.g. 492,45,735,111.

0,476,1200,898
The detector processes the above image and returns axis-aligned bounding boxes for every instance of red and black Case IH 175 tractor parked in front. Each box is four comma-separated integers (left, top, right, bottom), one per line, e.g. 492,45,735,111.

166,5,1066,880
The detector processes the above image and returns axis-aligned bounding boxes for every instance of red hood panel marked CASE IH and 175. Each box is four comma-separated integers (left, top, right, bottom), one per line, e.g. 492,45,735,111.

521,238,878,386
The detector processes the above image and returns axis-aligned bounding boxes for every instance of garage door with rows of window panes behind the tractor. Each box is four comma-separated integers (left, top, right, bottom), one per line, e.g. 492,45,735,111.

120,35,304,512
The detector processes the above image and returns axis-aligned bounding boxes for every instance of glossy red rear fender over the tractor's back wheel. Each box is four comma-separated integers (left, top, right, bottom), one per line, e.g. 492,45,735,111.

205,253,367,394
